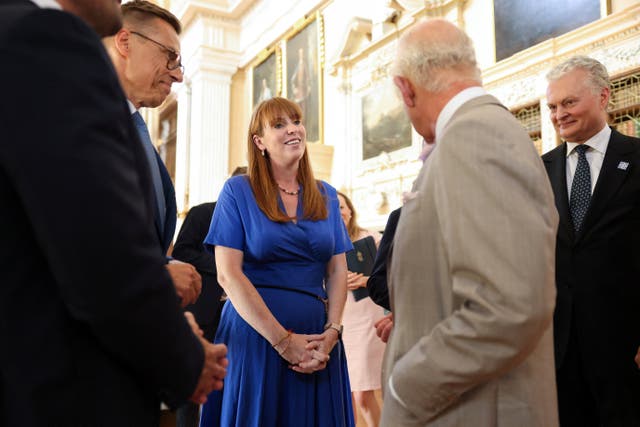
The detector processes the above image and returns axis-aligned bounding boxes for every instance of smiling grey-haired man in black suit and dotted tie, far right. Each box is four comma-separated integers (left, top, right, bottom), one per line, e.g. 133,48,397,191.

542,56,640,427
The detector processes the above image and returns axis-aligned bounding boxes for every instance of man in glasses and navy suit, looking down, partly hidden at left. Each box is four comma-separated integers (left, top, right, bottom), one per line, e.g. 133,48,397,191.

105,0,202,307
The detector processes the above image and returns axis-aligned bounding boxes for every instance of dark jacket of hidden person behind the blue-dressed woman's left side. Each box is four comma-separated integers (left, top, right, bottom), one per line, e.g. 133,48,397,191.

173,202,222,340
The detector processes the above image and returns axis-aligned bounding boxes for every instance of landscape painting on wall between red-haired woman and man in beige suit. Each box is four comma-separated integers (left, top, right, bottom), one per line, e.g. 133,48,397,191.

362,79,411,160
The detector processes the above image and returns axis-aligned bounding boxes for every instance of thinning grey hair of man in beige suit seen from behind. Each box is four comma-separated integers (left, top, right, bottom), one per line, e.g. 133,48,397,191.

392,19,482,92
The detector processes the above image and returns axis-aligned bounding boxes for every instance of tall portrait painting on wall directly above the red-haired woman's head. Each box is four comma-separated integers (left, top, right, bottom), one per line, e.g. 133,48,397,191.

286,19,321,142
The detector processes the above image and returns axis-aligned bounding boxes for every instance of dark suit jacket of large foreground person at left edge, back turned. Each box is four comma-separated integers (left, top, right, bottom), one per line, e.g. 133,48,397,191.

0,2,203,426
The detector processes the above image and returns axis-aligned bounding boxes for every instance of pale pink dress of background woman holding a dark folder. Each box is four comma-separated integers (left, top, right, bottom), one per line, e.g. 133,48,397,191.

342,231,385,391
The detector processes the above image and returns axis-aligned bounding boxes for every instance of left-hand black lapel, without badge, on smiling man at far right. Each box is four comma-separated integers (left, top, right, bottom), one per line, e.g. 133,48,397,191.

545,143,574,241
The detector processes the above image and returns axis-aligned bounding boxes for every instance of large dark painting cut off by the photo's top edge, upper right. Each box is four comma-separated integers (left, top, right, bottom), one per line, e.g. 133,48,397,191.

493,0,600,61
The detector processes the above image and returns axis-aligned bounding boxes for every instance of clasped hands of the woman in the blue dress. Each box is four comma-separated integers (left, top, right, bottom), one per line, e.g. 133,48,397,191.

276,329,338,374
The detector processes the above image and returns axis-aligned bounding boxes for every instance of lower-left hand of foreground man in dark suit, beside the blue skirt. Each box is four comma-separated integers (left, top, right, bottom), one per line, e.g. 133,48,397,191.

191,337,229,404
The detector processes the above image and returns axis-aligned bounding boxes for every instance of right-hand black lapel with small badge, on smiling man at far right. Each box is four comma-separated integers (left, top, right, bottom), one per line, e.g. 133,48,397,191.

582,130,637,235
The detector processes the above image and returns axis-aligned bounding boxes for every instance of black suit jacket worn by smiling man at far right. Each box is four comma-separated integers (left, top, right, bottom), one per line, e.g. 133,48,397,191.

542,130,640,404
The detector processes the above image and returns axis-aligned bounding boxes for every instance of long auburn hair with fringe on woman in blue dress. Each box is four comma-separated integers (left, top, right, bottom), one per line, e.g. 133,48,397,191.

247,97,329,222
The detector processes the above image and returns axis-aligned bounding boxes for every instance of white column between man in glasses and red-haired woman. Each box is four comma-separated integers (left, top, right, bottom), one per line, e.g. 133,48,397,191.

176,6,240,212
